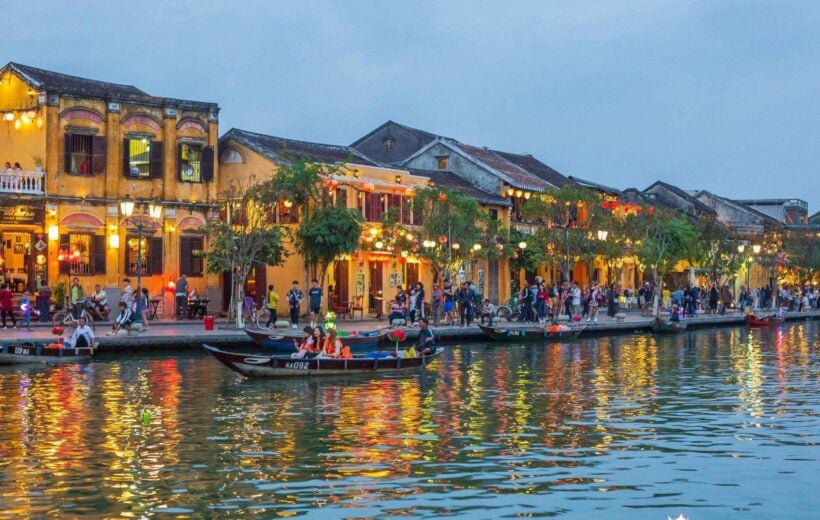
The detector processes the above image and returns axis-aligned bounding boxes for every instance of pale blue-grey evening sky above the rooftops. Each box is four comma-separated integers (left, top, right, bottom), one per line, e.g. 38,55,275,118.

0,0,820,214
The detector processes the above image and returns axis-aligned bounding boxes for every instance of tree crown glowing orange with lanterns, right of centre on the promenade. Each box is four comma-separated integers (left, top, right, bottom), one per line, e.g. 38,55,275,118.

521,185,601,280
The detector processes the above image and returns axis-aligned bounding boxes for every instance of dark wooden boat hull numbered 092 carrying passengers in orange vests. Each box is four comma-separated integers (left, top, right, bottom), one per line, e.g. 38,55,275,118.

202,345,442,377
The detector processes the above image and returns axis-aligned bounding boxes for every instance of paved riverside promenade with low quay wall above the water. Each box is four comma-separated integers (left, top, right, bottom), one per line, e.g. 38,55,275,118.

0,311,820,352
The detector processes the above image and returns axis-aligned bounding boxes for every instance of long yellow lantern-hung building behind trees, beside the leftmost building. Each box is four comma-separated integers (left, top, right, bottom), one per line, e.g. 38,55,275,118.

219,129,507,316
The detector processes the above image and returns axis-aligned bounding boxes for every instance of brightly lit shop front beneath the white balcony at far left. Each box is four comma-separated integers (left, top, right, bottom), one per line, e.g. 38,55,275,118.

0,201,48,293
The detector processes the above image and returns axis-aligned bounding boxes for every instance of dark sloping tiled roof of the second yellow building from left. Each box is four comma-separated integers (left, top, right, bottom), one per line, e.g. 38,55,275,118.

219,128,379,166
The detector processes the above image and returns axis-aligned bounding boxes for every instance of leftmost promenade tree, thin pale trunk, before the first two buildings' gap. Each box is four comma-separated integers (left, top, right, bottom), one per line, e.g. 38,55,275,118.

205,180,287,328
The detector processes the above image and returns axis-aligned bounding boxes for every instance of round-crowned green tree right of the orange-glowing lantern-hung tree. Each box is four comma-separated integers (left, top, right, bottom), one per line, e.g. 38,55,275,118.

636,210,697,314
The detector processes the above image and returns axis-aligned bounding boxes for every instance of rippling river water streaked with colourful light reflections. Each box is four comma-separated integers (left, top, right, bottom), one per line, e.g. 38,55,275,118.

0,322,820,518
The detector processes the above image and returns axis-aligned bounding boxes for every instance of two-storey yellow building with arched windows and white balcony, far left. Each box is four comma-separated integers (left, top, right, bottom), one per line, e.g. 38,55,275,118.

0,63,219,310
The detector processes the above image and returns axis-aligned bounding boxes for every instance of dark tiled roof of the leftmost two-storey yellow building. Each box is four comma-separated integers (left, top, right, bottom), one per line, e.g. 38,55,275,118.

2,62,217,110
